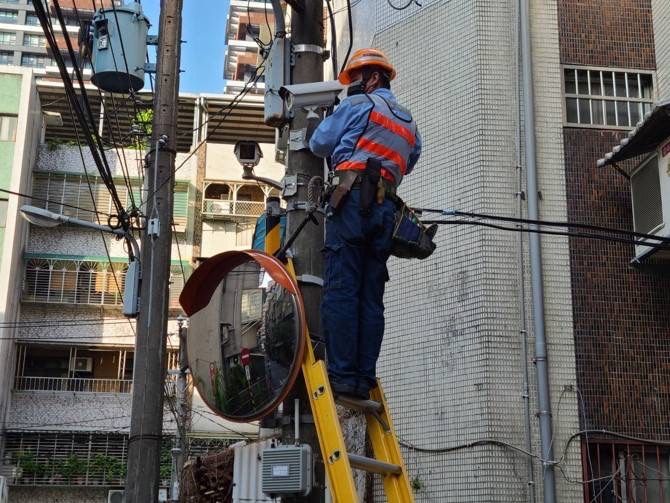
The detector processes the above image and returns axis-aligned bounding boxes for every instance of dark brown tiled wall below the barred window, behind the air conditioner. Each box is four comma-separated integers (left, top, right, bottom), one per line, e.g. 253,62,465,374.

565,129,670,441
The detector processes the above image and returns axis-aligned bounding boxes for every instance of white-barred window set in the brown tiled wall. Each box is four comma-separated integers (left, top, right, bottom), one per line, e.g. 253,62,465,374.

563,67,654,128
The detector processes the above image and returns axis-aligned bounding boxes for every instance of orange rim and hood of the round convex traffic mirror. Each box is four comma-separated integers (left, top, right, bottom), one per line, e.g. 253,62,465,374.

179,250,307,423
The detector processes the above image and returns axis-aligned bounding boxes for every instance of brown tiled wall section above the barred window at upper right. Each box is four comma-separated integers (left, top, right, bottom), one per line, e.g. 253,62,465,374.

558,0,660,69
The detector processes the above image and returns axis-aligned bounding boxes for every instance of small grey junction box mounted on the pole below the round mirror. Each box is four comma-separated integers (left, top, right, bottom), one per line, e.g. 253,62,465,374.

262,444,314,497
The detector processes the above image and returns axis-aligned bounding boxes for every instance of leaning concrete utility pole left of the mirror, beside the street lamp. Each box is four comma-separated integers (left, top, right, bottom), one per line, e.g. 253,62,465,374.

125,0,182,503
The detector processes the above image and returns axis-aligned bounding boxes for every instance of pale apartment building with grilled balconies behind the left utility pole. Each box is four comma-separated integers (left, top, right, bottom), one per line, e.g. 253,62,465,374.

0,67,281,502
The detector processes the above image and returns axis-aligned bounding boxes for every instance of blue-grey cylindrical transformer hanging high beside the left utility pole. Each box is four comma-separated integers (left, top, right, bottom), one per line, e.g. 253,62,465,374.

91,2,150,94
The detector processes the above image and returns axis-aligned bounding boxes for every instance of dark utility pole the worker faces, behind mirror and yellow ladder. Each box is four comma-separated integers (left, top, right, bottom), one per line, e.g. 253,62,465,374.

284,1,325,503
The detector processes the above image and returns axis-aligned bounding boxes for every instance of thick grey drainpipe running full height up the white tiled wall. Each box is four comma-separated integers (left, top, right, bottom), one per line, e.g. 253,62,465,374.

520,0,556,503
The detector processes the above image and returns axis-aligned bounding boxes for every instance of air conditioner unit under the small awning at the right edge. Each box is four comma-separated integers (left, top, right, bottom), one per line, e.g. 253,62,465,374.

630,141,670,262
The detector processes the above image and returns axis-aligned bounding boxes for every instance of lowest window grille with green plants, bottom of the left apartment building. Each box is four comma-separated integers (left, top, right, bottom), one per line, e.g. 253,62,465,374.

3,434,173,487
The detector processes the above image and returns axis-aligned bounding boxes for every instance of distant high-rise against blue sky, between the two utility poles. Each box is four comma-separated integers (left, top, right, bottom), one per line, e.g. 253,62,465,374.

223,0,275,94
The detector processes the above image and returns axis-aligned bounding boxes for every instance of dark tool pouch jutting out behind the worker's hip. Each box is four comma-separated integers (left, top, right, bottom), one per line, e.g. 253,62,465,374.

391,198,437,260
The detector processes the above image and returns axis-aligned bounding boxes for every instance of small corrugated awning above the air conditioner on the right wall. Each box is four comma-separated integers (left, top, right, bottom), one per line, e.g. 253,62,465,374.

598,100,670,171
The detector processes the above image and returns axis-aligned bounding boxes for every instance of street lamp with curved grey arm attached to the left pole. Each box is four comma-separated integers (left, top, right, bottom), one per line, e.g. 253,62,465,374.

21,204,142,318
